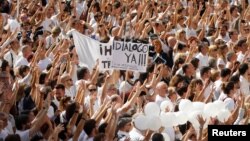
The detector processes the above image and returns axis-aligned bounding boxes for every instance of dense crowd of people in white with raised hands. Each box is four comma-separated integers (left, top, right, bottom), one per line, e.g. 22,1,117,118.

0,0,250,141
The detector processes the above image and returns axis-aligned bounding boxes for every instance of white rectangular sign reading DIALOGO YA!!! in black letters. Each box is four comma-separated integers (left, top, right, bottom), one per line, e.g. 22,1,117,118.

111,41,148,72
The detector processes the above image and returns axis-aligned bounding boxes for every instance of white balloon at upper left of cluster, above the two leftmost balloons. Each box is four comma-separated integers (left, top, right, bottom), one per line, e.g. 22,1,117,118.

144,102,161,116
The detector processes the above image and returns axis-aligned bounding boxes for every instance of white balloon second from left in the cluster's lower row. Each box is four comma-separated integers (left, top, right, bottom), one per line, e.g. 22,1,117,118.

145,116,162,131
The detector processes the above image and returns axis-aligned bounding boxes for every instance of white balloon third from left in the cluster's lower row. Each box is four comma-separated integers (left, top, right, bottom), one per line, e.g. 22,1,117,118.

161,112,176,128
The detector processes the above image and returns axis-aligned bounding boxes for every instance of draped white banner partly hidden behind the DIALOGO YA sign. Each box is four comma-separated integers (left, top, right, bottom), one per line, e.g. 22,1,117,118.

72,30,113,70
